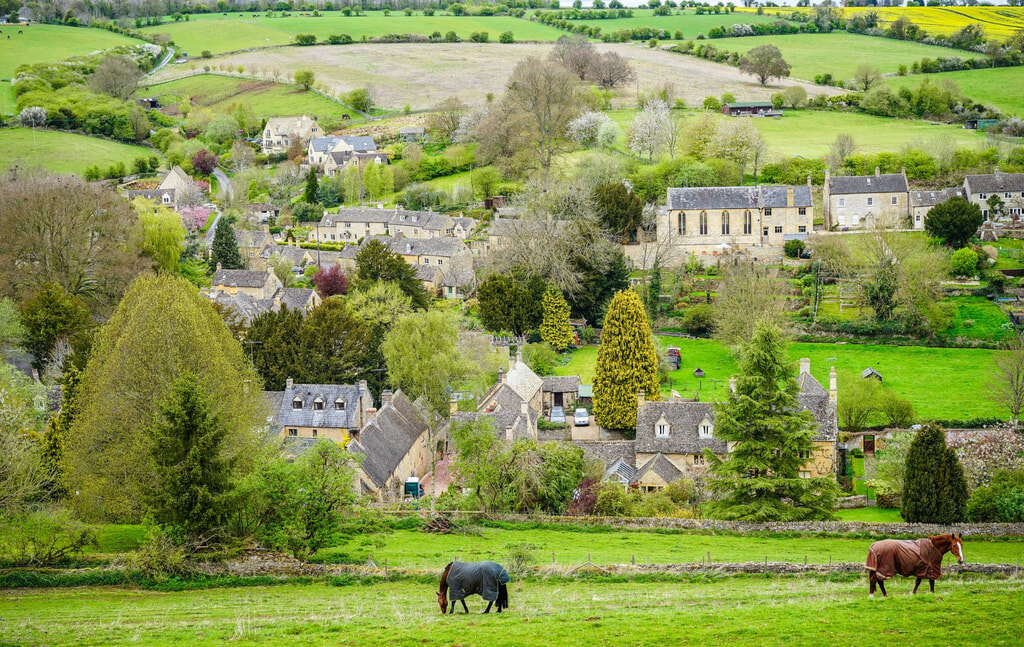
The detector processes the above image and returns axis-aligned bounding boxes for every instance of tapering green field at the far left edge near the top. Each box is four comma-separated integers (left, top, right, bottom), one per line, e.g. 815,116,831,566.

0,24,142,79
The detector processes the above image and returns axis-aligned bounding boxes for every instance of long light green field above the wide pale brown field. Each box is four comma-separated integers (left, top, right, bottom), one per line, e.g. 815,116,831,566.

145,11,564,56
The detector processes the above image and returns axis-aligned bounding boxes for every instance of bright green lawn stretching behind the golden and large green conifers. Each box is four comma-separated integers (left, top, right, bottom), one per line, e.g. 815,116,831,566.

555,337,1007,420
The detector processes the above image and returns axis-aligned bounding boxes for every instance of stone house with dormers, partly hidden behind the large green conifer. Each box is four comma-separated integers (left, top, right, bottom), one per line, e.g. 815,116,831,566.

620,358,839,489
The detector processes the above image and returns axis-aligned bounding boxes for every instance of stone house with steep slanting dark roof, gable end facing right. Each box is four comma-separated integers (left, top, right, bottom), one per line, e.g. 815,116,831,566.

347,390,431,502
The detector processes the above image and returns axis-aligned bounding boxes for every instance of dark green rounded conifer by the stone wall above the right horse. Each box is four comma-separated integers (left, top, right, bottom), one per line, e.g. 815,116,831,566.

900,425,968,524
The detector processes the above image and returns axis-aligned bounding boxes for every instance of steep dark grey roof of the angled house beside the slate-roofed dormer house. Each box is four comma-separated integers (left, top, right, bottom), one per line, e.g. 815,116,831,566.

348,390,427,488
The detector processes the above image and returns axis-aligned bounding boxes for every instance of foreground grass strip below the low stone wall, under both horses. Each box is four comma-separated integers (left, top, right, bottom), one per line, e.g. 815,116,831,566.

0,573,1024,647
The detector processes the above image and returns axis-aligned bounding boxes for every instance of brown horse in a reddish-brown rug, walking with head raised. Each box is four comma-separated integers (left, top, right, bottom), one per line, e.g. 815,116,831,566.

864,534,964,598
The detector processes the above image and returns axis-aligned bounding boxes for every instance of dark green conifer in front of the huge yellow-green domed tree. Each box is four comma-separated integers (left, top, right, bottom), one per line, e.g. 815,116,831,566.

148,373,233,540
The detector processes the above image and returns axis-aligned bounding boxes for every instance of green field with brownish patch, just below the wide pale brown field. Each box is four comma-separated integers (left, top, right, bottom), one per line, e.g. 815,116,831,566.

138,74,350,119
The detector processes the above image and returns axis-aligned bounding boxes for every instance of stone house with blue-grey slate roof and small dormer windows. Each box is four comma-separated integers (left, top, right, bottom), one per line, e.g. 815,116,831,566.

269,378,374,446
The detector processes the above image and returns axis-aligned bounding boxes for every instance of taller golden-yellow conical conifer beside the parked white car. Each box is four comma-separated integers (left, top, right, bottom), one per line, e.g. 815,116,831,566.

594,289,662,438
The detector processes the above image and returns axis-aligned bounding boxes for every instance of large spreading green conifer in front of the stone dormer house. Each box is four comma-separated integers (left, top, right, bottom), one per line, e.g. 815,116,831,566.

706,322,839,522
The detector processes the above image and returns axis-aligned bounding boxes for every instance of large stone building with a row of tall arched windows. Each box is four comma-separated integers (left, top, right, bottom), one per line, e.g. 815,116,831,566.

657,179,814,258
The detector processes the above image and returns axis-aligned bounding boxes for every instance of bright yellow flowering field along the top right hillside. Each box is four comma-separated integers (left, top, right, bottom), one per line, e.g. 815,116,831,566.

737,6,1024,40
